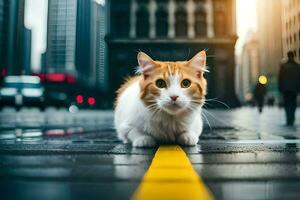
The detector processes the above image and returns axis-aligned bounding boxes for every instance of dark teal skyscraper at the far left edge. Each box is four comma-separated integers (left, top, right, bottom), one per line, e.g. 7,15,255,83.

0,0,25,74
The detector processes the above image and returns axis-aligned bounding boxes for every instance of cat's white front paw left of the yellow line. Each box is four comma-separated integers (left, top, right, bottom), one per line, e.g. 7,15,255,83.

128,128,157,147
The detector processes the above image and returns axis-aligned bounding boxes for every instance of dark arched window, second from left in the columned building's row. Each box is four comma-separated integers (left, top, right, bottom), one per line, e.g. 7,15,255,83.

136,8,150,38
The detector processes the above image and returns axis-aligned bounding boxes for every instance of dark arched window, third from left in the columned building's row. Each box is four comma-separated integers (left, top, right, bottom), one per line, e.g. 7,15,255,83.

156,8,169,37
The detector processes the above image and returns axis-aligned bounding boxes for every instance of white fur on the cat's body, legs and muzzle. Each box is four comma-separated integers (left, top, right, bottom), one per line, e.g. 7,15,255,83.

115,76,203,147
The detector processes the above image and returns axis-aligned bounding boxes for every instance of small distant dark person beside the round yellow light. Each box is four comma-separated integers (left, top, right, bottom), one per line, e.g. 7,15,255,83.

253,76,267,113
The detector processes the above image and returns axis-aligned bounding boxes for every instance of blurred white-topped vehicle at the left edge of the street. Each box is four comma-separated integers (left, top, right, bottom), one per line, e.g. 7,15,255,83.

0,76,45,110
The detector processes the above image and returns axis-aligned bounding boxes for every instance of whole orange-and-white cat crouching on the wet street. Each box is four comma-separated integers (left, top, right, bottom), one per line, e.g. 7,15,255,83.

115,51,207,147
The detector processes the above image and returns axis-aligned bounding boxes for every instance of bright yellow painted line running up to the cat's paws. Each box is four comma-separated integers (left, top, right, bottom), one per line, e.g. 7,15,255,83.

132,145,213,200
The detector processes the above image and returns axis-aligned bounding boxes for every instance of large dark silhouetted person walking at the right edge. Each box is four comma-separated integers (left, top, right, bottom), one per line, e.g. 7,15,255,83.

278,51,300,126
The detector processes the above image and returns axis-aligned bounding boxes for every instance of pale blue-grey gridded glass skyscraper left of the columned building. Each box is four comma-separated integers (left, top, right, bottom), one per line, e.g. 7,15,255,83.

44,0,77,75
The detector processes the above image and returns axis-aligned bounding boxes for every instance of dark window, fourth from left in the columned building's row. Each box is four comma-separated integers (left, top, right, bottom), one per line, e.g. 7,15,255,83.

175,9,187,37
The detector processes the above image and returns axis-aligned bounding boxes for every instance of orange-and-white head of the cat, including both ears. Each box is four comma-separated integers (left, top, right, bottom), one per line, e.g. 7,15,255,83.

137,51,207,115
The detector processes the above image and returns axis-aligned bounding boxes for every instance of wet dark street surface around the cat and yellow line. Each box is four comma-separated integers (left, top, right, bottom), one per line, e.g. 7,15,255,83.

0,108,300,200
